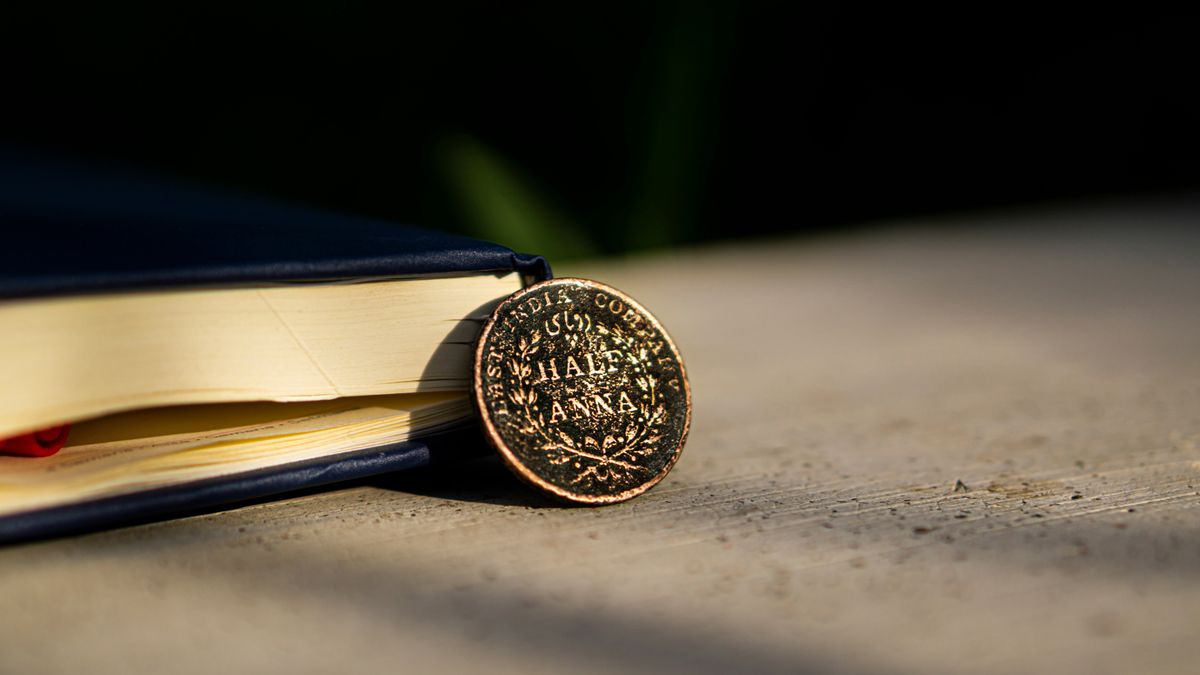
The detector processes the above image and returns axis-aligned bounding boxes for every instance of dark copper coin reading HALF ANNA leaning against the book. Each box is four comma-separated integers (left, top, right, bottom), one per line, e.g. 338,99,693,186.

474,277,691,504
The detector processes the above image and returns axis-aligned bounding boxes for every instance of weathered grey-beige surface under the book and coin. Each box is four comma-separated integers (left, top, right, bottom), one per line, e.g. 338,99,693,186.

0,201,1200,673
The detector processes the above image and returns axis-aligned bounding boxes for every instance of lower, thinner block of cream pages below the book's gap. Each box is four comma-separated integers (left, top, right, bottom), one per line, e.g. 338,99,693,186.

0,393,470,515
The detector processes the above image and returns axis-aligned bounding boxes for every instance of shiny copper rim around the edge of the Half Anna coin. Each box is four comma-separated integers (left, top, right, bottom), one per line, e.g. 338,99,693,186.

472,276,691,504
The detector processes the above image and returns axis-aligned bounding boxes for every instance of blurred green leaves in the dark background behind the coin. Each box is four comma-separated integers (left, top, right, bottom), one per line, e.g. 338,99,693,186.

436,2,732,261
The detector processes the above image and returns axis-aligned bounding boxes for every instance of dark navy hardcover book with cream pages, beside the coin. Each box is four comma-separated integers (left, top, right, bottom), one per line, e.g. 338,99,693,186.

0,153,551,540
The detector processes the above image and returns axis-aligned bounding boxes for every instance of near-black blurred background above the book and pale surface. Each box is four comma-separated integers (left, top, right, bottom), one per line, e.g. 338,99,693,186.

0,2,1200,257
